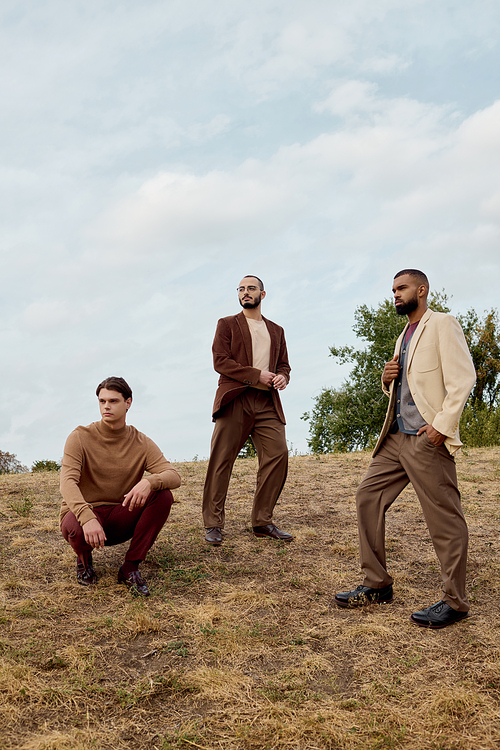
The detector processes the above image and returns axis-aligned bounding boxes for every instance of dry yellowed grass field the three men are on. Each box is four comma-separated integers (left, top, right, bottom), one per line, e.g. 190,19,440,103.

0,449,500,750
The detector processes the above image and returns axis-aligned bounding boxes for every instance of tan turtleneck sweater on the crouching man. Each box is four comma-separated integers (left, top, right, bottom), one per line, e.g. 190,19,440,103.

59,421,181,526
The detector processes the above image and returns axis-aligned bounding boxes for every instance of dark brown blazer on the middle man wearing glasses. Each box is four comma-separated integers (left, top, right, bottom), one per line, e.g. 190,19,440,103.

212,312,290,424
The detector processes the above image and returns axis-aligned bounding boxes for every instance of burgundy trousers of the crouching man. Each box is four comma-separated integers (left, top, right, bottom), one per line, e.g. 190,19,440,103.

61,490,174,565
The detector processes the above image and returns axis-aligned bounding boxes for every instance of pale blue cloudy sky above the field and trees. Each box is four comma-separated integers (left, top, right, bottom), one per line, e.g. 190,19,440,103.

0,0,500,466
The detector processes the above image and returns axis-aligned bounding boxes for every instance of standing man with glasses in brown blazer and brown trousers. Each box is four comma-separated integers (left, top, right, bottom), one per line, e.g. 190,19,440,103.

203,276,293,545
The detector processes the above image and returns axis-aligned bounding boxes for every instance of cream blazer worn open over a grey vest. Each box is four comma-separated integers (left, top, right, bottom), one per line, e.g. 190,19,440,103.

373,309,476,456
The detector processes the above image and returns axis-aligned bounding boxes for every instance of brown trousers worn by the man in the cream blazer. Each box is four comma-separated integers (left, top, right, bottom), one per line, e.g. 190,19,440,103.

356,432,469,612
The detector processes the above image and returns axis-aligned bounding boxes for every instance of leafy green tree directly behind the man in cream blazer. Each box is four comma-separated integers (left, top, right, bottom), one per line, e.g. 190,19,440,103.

302,291,450,453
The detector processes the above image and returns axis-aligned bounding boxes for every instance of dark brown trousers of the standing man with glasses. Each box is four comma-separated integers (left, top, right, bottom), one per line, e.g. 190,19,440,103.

203,388,288,528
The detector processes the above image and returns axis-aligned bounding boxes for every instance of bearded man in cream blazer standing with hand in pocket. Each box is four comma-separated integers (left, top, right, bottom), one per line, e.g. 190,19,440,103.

335,269,476,628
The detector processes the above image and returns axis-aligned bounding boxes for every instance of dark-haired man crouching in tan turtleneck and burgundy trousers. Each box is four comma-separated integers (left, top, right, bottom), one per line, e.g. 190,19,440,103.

60,377,181,596
